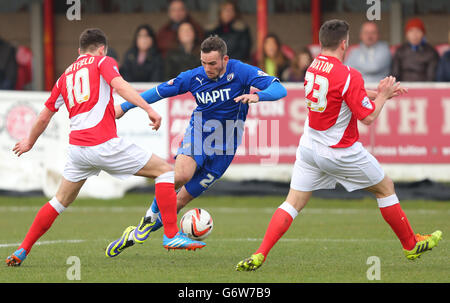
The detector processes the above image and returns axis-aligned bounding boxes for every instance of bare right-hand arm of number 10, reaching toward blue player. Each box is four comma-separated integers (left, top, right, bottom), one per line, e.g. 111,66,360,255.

111,77,161,130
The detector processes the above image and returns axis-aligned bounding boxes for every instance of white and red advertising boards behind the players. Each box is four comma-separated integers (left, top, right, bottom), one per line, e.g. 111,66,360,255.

0,83,450,198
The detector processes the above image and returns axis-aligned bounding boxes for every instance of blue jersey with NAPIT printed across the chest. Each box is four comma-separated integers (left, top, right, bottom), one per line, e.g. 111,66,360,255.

156,59,279,149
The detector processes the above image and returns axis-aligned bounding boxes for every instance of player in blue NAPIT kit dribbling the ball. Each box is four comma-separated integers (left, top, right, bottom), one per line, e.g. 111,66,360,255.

106,36,287,257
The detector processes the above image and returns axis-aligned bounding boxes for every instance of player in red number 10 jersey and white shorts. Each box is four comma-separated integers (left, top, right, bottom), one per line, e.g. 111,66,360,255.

6,29,205,266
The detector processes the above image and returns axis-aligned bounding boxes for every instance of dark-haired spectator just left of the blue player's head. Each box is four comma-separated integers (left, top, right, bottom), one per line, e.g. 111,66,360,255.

166,21,200,79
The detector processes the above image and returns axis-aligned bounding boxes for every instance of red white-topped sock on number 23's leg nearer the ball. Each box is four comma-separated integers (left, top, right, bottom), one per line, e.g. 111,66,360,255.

255,202,298,260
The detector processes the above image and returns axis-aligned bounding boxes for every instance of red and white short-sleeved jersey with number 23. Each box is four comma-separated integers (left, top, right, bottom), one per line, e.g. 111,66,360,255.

304,55,375,148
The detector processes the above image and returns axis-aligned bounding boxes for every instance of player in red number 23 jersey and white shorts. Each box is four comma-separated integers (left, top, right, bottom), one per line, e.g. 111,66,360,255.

236,20,442,271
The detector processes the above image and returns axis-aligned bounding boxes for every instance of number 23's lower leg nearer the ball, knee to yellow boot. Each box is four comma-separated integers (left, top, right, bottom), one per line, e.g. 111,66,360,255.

236,188,311,271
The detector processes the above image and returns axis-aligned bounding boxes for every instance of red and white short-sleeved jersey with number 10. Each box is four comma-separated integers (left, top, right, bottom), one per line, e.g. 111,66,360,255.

45,55,120,146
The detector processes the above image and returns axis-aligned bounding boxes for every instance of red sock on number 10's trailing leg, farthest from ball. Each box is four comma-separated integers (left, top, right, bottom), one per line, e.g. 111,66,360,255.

19,200,64,255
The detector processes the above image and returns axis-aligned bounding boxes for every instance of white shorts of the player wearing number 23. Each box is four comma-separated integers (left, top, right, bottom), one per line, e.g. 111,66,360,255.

291,142,384,192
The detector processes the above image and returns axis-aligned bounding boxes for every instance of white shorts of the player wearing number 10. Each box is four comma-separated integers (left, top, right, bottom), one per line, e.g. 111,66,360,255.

63,138,152,182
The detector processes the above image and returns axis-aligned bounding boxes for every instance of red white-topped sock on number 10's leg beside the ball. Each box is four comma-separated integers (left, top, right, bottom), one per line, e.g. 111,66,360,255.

155,171,178,238
